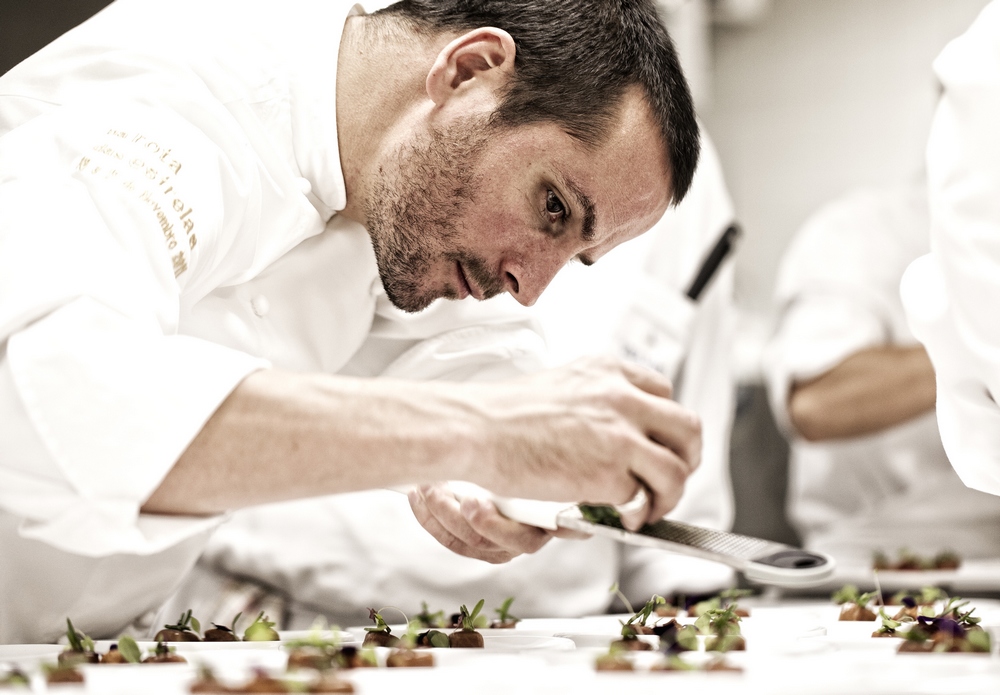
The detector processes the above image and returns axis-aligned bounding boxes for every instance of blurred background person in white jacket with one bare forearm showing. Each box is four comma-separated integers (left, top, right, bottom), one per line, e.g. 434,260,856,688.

764,184,1000,577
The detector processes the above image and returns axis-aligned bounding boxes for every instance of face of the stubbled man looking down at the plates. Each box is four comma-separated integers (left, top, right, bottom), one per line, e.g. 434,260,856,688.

365,93,670,312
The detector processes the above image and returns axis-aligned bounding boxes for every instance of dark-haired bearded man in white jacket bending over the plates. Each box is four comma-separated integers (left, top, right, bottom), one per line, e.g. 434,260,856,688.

0,0,700,642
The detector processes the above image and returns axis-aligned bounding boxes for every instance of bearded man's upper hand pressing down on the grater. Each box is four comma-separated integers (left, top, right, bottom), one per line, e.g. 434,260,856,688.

472,357,701,529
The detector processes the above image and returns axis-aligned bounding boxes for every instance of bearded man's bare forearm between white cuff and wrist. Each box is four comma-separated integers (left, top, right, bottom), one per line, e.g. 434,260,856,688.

142,370,476,514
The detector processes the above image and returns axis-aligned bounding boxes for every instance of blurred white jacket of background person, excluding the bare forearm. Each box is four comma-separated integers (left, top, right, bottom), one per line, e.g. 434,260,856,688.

764,182,1000,569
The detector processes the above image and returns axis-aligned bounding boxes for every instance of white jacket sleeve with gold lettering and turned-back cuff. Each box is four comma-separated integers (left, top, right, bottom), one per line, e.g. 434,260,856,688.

0,94,267,557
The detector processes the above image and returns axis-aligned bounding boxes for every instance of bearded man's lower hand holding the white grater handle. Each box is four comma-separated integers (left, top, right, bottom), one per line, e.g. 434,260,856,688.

408,484,586,564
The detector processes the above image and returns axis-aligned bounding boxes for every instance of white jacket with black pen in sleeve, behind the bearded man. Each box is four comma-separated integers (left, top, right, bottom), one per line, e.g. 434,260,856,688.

168,130,734,629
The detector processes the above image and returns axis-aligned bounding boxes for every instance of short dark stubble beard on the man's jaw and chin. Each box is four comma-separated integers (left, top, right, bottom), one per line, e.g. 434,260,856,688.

365,119,504,313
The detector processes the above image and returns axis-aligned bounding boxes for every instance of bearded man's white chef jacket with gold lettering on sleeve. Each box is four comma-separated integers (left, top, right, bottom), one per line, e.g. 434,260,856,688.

0,0,542,642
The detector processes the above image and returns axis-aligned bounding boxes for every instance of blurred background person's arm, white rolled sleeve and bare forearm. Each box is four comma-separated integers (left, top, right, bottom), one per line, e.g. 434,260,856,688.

763,185,934,441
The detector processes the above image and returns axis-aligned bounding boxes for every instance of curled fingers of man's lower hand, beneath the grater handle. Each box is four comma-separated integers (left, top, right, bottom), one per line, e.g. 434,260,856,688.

407,486,514,564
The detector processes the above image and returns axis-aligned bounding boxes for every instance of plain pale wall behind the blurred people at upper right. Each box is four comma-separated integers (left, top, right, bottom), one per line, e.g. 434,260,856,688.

699,0,987,380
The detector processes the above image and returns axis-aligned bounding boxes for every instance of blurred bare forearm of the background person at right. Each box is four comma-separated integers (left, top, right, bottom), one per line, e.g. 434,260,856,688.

788,346,935,441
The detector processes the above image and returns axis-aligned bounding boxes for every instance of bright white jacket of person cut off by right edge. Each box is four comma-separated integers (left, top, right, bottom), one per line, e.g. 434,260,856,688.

901,1,1000,495
